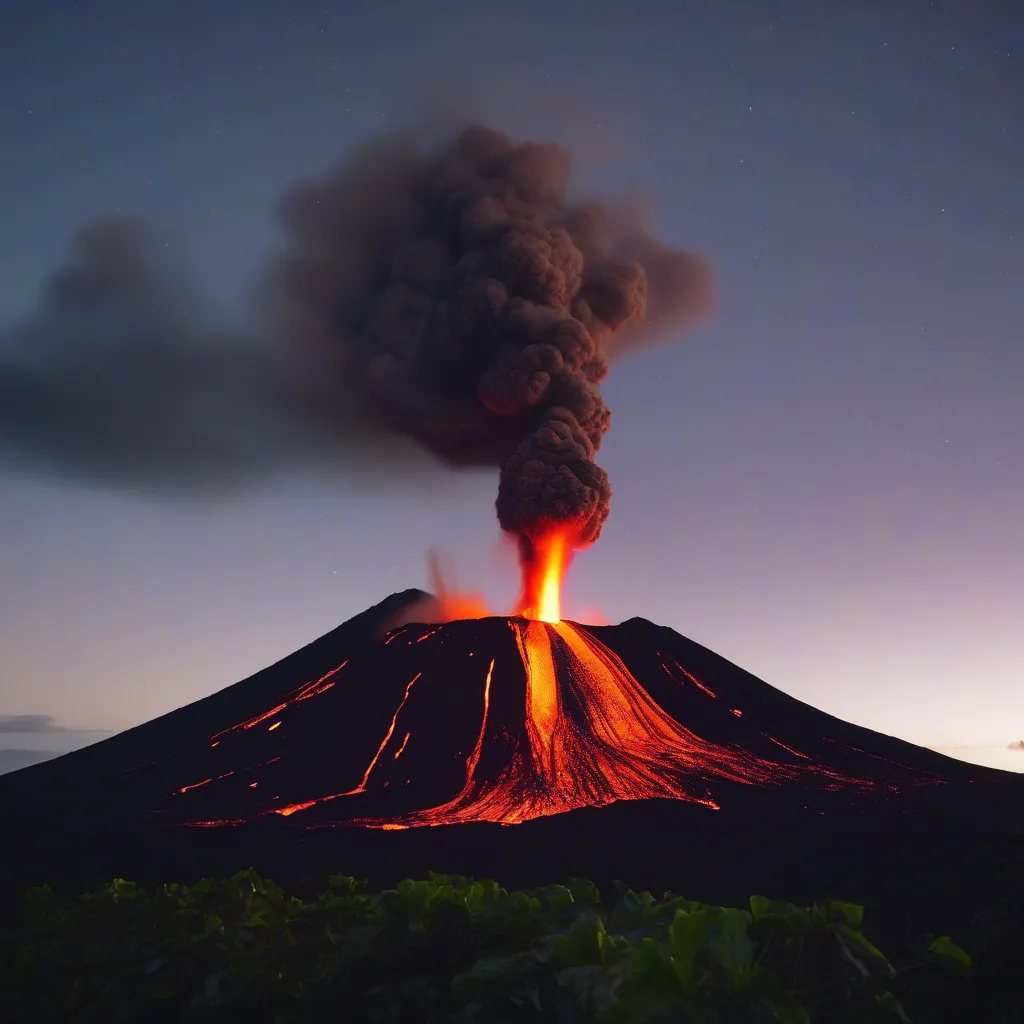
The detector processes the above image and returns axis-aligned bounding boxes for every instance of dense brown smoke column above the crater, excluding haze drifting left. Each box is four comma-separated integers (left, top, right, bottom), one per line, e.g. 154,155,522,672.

278,127,711,556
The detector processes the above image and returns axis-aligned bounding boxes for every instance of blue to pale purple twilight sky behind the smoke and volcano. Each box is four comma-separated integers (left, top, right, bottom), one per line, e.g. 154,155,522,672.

0,0,1024,771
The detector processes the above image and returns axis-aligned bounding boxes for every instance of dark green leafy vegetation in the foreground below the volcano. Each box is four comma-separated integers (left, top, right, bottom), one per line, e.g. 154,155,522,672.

0,871,1024,1024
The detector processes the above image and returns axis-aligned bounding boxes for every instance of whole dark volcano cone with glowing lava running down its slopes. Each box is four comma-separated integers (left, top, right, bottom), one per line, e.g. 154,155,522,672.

0,591,1024,937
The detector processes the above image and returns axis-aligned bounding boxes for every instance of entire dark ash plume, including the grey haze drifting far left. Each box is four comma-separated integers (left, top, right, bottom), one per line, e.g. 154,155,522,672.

0,126,713,552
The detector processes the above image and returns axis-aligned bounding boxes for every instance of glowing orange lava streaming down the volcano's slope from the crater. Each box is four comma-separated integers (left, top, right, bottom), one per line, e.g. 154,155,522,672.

204,618,880,828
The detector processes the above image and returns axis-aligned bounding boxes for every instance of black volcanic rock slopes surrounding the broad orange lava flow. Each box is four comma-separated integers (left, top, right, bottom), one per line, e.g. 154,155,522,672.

0,591,1024,946
